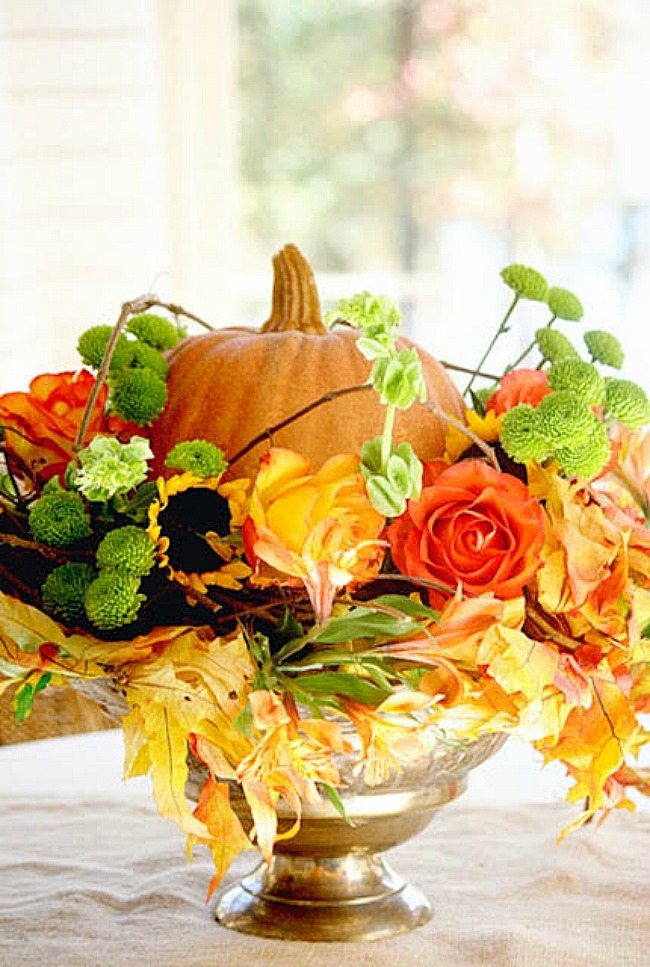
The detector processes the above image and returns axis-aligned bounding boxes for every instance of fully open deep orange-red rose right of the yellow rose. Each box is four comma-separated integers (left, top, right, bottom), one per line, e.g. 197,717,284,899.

388,460,545,606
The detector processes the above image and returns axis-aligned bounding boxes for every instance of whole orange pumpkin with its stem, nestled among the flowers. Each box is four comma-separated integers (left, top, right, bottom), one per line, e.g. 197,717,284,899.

151,245,464,477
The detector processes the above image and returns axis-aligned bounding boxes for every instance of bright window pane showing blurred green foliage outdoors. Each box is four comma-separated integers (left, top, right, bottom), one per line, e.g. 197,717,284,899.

238,0,650,378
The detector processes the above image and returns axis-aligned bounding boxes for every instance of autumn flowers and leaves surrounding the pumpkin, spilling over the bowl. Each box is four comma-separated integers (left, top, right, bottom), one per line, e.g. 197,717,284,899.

0,265,650,900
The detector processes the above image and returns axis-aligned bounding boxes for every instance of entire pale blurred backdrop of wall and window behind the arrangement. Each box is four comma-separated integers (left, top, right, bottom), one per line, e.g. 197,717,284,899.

0,0,650,389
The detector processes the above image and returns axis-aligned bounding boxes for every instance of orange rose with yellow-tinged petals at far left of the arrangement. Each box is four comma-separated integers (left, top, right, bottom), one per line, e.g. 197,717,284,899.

0,370,131,481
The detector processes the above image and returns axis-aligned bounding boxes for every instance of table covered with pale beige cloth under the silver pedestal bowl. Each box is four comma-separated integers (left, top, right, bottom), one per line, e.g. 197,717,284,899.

0,733,650,967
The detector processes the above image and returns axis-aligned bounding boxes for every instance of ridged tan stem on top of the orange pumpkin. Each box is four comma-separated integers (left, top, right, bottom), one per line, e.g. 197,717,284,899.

261,245,327,335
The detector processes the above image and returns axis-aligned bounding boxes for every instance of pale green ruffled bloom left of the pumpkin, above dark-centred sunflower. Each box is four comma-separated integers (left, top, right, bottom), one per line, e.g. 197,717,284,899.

73,435,153,501
